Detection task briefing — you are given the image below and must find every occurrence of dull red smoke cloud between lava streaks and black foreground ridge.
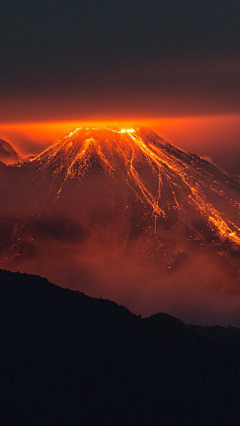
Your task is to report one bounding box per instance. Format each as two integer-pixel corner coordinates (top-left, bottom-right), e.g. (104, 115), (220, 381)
(0, 170), (240, 326)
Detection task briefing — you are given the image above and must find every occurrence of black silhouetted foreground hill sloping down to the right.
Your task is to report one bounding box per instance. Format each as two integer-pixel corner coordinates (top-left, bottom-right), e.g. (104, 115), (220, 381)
(0, 271), (240, 426)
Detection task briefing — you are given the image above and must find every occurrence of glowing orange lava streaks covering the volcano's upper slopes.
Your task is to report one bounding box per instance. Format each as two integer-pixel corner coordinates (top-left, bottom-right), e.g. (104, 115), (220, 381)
(31, 128), (240, 249)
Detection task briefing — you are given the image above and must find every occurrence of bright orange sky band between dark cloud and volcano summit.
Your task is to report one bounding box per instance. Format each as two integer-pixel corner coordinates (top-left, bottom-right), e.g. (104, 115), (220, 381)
(0, 114), (240, 173)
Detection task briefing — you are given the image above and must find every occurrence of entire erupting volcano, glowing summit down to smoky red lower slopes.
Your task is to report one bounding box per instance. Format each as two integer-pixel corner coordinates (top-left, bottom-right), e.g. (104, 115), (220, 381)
(0, 128), (240, 321)
